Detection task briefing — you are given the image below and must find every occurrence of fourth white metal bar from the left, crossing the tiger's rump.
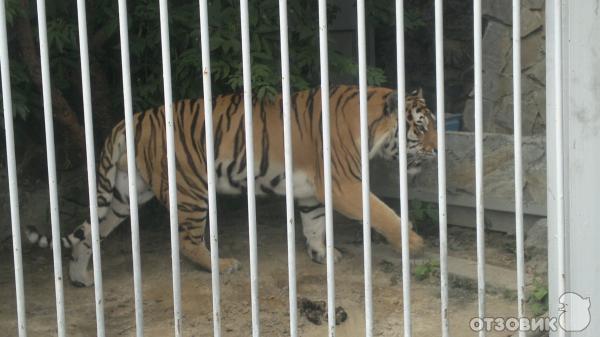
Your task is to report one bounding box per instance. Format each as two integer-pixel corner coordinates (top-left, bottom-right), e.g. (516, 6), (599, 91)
(119, 0), (144, 337)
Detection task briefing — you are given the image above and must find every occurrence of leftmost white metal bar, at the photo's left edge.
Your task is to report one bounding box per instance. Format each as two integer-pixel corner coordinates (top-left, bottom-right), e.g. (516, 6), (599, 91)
(0, 0), (27, 337)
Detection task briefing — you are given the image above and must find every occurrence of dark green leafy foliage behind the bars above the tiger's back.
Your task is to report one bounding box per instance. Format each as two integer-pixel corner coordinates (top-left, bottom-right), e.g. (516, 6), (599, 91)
(7, 0), (423, 120)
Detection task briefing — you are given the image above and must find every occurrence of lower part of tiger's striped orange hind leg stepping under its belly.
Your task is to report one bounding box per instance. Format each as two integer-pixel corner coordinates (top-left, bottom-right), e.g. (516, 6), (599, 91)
(178, 202), (240, 273)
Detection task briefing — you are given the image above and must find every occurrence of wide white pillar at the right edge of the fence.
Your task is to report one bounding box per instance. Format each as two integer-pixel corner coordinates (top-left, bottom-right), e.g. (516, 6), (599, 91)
(546, 0), (600, 337)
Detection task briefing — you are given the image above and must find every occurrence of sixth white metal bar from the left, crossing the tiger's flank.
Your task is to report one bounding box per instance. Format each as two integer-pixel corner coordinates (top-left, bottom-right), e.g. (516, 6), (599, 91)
(199, 0), (221, 337)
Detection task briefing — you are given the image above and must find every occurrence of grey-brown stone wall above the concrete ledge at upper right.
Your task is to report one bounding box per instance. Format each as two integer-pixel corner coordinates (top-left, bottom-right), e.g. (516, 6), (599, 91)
(463, 0), (546, 135)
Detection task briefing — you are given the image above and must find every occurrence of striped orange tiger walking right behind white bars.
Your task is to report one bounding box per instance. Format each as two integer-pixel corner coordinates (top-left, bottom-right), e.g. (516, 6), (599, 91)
(28, 85), (437, 286)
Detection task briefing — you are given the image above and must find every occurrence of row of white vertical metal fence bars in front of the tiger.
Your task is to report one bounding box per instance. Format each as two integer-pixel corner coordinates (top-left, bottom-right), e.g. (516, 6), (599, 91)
(0, 0), (592, 337)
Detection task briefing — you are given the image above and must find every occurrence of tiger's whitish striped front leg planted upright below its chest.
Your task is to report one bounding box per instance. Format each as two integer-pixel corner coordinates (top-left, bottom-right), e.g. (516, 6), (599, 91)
(298, 198), (342, 263)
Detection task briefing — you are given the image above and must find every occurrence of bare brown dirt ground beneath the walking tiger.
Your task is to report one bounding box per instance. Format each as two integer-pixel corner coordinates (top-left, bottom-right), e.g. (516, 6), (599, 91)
(0, 199), (516, 337)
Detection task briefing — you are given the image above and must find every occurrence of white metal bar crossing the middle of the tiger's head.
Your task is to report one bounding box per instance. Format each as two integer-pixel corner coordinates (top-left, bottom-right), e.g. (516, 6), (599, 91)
(396, 0), (412, 337)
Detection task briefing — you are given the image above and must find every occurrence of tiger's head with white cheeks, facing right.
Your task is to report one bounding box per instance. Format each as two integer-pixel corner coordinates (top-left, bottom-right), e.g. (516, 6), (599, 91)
(378, 89), (437, 175)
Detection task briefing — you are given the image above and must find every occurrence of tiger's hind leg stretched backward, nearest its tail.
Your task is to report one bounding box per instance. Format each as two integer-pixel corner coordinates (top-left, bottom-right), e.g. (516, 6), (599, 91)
(62, 171), (154, 287)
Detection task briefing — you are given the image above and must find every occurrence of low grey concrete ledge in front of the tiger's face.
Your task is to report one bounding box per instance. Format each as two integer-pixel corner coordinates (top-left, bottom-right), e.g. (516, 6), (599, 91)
(371, 132), (546, 233)
